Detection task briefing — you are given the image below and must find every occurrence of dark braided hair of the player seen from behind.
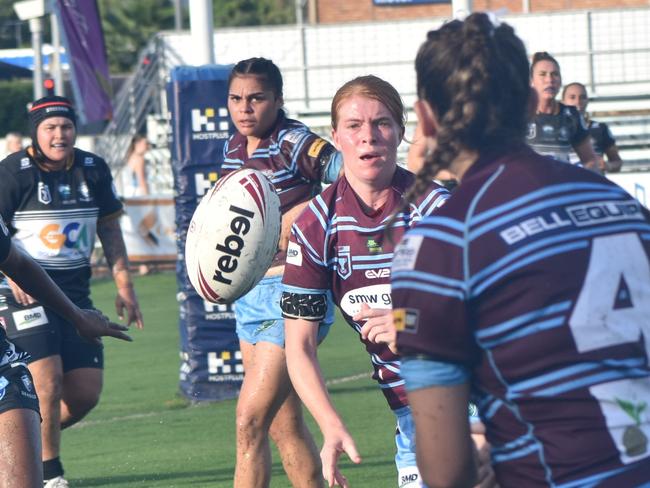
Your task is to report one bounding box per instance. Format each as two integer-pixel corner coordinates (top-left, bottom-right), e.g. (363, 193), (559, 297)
(405, 13), (530, 206)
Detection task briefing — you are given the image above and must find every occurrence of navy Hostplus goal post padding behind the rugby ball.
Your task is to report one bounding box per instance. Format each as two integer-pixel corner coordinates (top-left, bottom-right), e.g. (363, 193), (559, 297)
(167, 65), (244, 402)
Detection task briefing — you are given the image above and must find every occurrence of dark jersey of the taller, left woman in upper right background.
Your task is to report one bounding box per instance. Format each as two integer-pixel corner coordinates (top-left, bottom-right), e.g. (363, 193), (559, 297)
(527, 103), (589, 163)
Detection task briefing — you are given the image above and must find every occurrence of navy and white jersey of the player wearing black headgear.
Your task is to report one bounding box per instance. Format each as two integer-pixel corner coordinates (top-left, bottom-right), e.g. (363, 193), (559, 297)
(0, 149), (122, 301)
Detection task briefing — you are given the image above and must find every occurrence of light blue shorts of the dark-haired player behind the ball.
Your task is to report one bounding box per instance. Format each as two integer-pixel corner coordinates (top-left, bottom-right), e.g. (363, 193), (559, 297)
(235, 275), (334, 347)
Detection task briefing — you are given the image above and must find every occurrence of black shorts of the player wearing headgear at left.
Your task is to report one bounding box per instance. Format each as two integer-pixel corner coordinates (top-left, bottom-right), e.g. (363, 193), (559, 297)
(0, 292), (104, 372)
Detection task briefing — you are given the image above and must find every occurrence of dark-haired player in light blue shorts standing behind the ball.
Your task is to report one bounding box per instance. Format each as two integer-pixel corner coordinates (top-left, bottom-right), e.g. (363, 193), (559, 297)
(222, 58), (340, 488)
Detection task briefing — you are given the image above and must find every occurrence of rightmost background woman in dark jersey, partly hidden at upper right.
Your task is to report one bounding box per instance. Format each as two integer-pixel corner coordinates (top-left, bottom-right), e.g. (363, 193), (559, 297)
(562, 82), (623, 173)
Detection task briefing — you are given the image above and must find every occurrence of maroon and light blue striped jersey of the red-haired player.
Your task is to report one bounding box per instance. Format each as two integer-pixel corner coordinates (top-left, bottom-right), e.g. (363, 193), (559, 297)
(283, 168), (448, 409)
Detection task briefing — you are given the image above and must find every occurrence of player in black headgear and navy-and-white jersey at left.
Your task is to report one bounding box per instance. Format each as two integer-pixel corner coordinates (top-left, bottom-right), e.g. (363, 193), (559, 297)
(0, 96), (143, 488)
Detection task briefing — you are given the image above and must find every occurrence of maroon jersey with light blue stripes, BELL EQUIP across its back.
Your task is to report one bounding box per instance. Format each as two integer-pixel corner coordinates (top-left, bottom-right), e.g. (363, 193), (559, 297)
(392, 146), (650, 487)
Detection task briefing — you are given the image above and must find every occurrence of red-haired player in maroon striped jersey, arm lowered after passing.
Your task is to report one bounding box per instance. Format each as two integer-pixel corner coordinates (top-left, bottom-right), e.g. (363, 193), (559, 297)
(282, 76), (450, 487)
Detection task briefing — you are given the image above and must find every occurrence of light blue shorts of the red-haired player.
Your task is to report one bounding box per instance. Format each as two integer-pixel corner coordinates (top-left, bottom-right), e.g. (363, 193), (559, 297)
(393, 407), (426, 488)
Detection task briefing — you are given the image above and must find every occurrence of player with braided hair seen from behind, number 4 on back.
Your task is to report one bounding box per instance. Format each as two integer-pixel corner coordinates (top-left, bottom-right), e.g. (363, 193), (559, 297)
(392, 13), (650, 487)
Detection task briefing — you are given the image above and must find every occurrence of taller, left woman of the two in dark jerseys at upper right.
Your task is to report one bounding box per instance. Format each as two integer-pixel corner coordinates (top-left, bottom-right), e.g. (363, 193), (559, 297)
(527, 51), (600, 171)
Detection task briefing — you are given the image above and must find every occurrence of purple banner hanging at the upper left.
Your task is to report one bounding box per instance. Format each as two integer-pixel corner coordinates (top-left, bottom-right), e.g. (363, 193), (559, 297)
(54, 0), (113, 124)
